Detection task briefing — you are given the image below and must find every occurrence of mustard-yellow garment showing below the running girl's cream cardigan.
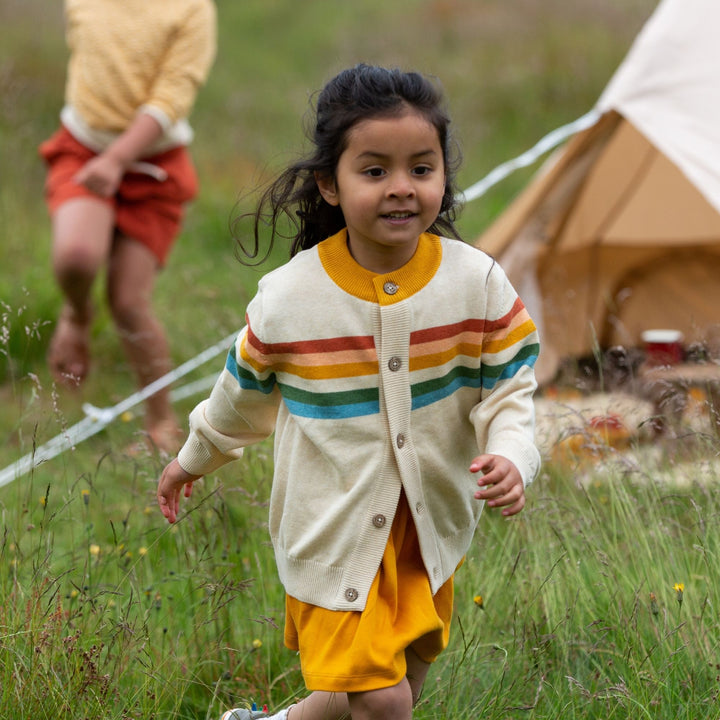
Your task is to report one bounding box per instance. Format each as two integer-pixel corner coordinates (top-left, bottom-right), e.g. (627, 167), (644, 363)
(285, 494), (453, 692)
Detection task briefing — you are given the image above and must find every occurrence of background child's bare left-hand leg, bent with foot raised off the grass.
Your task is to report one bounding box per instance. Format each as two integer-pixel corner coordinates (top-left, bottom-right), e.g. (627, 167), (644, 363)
(48, 198), (114, 387)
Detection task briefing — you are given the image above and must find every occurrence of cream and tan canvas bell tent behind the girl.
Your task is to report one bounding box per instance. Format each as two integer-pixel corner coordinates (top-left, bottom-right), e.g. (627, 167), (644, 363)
(476, 0), (720, 383)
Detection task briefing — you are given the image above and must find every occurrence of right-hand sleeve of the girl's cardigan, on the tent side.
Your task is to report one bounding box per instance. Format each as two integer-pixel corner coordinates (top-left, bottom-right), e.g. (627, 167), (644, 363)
(470, 265), (540, 486)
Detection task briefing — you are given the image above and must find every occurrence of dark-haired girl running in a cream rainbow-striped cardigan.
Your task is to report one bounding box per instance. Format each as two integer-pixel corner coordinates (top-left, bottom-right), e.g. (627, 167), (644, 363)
(158, 65), (539, 720)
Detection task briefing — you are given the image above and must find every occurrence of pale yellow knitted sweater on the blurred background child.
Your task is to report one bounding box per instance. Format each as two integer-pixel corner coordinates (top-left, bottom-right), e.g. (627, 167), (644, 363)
(62, 0), (216, 150)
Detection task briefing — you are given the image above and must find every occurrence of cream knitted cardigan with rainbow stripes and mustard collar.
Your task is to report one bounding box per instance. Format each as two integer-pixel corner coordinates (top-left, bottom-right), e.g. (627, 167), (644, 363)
(179, 231), (540, 610)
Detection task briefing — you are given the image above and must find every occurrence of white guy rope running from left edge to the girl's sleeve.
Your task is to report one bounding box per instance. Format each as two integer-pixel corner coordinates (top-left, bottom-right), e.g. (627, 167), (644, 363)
(0, 332), (237, 487)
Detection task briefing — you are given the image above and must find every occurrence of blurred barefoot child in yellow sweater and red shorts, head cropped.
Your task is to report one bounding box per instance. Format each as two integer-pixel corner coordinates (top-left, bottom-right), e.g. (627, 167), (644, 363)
(40, 0), (216, 452)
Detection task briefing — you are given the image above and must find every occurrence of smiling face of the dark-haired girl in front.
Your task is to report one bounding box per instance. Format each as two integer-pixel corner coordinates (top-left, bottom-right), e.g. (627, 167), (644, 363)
(316, 110), (445, 273)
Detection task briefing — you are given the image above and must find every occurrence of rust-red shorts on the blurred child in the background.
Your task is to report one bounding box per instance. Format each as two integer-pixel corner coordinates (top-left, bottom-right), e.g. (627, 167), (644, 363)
(39, 127), (198, 265)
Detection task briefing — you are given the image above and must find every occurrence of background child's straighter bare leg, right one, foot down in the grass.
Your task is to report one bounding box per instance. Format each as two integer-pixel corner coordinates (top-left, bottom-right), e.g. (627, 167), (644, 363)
(108, 237), (181, 453)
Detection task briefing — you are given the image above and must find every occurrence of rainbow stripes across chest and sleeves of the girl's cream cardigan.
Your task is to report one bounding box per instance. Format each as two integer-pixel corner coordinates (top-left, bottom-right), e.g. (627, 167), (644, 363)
(227, 231), (539, 419)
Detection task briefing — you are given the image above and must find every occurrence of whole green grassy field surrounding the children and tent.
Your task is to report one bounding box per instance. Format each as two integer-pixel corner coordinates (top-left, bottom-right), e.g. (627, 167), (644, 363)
(0, 0), (720, 720)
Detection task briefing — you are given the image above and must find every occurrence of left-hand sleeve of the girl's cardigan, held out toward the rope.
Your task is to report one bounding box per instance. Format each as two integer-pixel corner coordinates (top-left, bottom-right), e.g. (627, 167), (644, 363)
(178, 326), (280, 475)
